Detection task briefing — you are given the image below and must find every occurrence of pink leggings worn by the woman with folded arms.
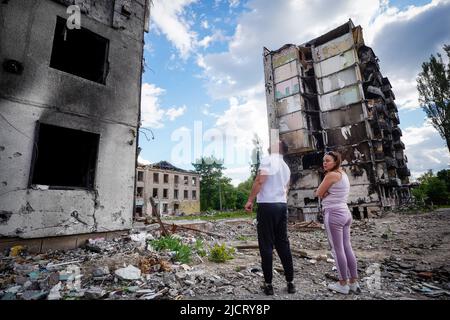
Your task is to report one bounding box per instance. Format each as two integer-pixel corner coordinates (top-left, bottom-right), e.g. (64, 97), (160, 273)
(324, 208), (358, 280)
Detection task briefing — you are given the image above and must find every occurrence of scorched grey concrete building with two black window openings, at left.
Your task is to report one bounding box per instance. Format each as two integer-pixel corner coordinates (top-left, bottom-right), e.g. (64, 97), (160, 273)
(0, 0), (151, 251)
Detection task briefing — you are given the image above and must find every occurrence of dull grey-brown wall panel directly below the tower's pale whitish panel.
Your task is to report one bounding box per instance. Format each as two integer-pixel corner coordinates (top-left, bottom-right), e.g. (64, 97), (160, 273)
(321, 103), (364, 129)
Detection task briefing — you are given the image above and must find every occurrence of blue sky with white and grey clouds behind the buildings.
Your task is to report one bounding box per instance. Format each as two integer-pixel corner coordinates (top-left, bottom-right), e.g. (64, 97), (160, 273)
(139, 0), (450, 183)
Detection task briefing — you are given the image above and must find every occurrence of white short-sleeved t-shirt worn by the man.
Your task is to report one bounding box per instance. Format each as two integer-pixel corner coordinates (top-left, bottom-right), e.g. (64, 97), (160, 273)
(256, 153), (291, 203)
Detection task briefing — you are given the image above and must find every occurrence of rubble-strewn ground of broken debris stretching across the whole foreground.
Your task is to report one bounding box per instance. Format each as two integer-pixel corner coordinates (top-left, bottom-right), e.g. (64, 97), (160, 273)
(0, 209), (450, 300)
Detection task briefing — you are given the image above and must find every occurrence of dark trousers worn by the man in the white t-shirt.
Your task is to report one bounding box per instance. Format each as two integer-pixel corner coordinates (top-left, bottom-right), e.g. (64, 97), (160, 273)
(256, 203), (294, 283)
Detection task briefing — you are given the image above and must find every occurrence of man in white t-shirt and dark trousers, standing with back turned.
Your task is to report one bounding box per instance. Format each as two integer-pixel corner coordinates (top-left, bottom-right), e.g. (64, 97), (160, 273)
(245, 141), (295, 295)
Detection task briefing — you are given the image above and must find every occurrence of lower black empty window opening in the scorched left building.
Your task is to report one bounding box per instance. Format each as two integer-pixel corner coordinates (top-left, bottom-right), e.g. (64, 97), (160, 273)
(28, 122), (100, 189)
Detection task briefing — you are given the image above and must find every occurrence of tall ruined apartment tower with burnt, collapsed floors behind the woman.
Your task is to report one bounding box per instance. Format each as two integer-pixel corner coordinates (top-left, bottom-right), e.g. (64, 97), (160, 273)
(263, 20), (410, 221)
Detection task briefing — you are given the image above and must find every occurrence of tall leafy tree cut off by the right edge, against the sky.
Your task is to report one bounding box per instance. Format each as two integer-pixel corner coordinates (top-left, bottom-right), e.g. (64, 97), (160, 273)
(417, 45), (450, 151)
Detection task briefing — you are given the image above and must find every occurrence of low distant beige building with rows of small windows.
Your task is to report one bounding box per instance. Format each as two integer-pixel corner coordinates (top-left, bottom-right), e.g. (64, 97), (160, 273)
(135, 161), (200, 219)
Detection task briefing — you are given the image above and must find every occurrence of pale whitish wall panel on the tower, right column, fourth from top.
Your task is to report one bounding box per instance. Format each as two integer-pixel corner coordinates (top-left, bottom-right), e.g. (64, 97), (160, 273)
(319, 85), (363, 111)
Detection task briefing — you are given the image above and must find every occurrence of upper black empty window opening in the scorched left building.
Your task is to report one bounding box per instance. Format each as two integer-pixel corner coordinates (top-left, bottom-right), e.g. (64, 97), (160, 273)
(50, 17), (109, 84)
